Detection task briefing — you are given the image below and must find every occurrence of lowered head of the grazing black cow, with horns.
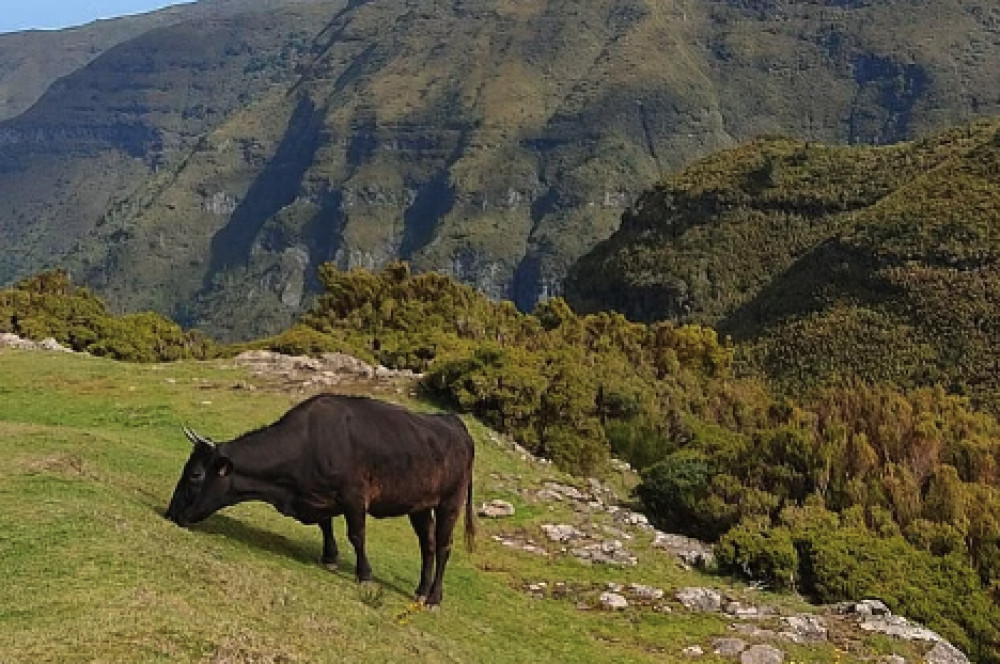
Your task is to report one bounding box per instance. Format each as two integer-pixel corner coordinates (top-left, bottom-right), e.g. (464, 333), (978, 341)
(165, 427), (233, 526)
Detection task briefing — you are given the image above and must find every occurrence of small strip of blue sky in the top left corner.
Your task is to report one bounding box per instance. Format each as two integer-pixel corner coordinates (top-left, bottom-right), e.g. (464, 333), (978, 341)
(0, 0), (193, 32)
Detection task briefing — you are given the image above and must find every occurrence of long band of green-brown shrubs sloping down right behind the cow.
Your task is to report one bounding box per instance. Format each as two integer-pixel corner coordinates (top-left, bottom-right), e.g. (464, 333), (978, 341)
(278, 265), (1000, 662)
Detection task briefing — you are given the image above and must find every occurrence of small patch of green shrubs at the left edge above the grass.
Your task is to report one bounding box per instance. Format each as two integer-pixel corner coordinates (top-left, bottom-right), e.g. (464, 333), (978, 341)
(0, 271), (213, 362)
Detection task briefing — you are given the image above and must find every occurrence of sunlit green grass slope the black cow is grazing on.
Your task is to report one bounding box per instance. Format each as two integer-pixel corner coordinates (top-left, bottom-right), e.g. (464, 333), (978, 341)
(0, 351), (920, 664)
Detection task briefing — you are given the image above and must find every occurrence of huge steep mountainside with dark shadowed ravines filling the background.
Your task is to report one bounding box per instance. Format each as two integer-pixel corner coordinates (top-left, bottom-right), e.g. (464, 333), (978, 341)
(0, 0), (1000, 338)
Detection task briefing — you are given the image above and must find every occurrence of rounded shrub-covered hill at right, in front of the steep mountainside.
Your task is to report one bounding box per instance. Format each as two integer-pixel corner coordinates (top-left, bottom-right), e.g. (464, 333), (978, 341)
(567, 120), (1000, 411)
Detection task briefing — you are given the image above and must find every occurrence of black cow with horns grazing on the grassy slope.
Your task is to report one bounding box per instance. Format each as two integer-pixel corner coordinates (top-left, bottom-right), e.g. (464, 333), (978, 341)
(166, 395), (475, 606)
